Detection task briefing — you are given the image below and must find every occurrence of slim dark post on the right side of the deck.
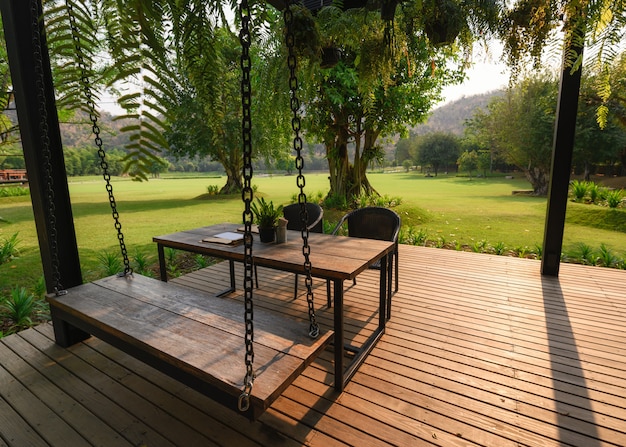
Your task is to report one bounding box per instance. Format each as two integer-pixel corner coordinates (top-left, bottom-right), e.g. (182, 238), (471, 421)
(541, 18), (584, 276)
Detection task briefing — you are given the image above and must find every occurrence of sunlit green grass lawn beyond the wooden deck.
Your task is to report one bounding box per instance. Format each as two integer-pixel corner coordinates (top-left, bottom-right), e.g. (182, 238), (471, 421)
(0, 173), (626, 290)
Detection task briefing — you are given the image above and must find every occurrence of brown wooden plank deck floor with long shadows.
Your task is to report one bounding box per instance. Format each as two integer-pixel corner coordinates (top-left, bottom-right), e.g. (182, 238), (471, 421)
(0, 246), (626, 447)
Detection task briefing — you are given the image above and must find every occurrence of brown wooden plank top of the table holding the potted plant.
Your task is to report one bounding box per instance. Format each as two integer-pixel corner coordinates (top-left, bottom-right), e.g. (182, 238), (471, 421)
(153, 224), (394, 280)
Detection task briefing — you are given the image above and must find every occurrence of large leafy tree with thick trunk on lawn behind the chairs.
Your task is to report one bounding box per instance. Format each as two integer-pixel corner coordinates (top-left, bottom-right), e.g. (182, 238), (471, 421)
(292, 2), (502, 202)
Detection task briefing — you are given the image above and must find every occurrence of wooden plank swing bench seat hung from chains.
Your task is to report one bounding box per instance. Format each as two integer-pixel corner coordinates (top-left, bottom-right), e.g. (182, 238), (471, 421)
(48, 275), (333, 419)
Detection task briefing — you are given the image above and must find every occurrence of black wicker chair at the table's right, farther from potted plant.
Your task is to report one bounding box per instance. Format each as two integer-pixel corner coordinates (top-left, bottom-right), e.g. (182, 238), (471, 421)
(326, 206), (401, 318)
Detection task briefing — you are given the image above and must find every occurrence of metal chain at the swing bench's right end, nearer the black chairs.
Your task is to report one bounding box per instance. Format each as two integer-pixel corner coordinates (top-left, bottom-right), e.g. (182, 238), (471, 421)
(283, 1), (320, 338)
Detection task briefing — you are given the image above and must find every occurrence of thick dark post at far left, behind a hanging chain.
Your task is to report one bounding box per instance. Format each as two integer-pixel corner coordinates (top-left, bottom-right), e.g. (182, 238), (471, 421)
(0, 0), (82, 292)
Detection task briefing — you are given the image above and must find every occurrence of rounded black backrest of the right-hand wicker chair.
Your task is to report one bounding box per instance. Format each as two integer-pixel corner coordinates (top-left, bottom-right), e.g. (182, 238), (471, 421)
(336, 206), (400, 242)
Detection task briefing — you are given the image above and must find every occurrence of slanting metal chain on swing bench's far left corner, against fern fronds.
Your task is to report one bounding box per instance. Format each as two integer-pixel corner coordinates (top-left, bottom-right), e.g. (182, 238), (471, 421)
(65, 1), (133, 276)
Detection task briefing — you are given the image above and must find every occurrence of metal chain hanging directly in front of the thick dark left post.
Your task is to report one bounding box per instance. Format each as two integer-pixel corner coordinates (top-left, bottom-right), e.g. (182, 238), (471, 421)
(30, 0), (67, 296)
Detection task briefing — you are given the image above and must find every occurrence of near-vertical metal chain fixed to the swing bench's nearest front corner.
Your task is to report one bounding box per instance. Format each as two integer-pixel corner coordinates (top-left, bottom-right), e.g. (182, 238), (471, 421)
(238, 0), (255, 411)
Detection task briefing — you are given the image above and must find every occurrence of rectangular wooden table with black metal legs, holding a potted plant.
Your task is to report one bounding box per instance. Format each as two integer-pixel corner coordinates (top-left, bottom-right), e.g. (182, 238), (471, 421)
(153, 224), (394, 392)
